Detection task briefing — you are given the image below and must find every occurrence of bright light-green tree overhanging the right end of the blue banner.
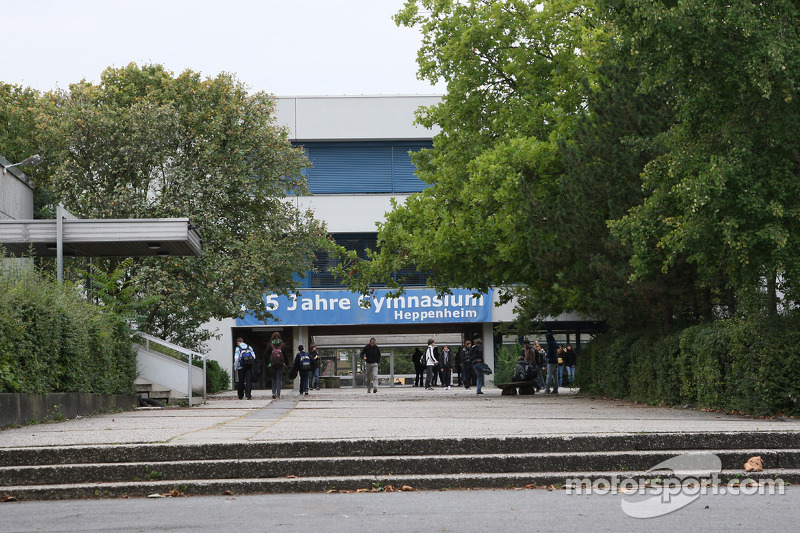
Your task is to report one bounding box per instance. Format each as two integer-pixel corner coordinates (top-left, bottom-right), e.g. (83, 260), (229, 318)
(340, 0), (593, 330)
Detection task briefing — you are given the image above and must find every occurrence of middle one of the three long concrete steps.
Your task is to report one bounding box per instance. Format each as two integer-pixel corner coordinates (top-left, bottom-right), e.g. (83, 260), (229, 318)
(0, 450), (800, 486)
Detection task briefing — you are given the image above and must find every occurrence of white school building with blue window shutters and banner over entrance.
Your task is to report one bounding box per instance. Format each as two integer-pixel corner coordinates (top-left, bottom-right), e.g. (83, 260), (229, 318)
(207, 95), (593, 387)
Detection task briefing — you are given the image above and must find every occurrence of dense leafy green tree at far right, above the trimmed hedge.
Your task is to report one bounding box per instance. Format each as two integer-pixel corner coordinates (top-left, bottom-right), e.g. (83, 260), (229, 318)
(603, 0), (800, 312)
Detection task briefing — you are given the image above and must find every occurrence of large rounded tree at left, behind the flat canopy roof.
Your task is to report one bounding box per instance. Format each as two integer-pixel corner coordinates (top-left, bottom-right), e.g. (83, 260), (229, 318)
(25, 64), (326, 345)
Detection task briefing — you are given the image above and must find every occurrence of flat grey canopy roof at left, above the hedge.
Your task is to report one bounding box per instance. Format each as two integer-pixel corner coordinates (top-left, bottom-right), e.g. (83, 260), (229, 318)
(0, 218), (202, 257)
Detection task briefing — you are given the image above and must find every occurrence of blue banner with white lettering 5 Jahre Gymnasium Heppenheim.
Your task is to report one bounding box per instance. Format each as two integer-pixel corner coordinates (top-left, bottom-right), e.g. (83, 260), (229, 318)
(236, 289), (492, 327)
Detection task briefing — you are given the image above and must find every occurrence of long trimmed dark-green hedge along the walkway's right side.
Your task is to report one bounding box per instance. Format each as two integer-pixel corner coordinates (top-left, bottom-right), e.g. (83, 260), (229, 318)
(577, 317), (800, 416)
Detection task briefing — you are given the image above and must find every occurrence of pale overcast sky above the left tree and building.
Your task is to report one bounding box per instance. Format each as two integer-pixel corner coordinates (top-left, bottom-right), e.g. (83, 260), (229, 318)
(0, 0), (444, 96)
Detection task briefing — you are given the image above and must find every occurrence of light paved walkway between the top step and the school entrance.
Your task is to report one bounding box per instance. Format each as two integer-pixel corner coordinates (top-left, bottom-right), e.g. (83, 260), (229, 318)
(0, 386), (800, 448)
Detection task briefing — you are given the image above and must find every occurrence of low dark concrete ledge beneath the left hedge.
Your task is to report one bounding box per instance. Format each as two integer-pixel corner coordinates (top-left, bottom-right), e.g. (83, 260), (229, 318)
(0, 392), (138, 427)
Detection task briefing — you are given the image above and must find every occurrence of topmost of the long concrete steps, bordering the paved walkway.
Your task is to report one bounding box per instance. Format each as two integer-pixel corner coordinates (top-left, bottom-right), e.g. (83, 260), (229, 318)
(6, 432), (800, 466)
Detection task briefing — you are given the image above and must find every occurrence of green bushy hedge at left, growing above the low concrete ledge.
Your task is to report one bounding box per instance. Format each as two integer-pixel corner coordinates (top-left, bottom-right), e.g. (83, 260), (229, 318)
(0, 270), (136, 394)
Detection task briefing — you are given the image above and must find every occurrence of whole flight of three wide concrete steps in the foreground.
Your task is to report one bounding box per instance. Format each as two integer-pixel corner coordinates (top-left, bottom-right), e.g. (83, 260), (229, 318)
(0, 432), (800, 500)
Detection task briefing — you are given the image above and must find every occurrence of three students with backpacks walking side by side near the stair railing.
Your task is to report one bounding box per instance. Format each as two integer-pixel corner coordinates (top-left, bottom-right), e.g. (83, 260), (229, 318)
(233, 331), (320, 400)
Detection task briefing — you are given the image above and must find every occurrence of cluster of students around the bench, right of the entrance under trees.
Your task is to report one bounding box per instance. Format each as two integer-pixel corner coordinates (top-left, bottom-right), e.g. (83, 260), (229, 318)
(511, 331), (578, 394)
